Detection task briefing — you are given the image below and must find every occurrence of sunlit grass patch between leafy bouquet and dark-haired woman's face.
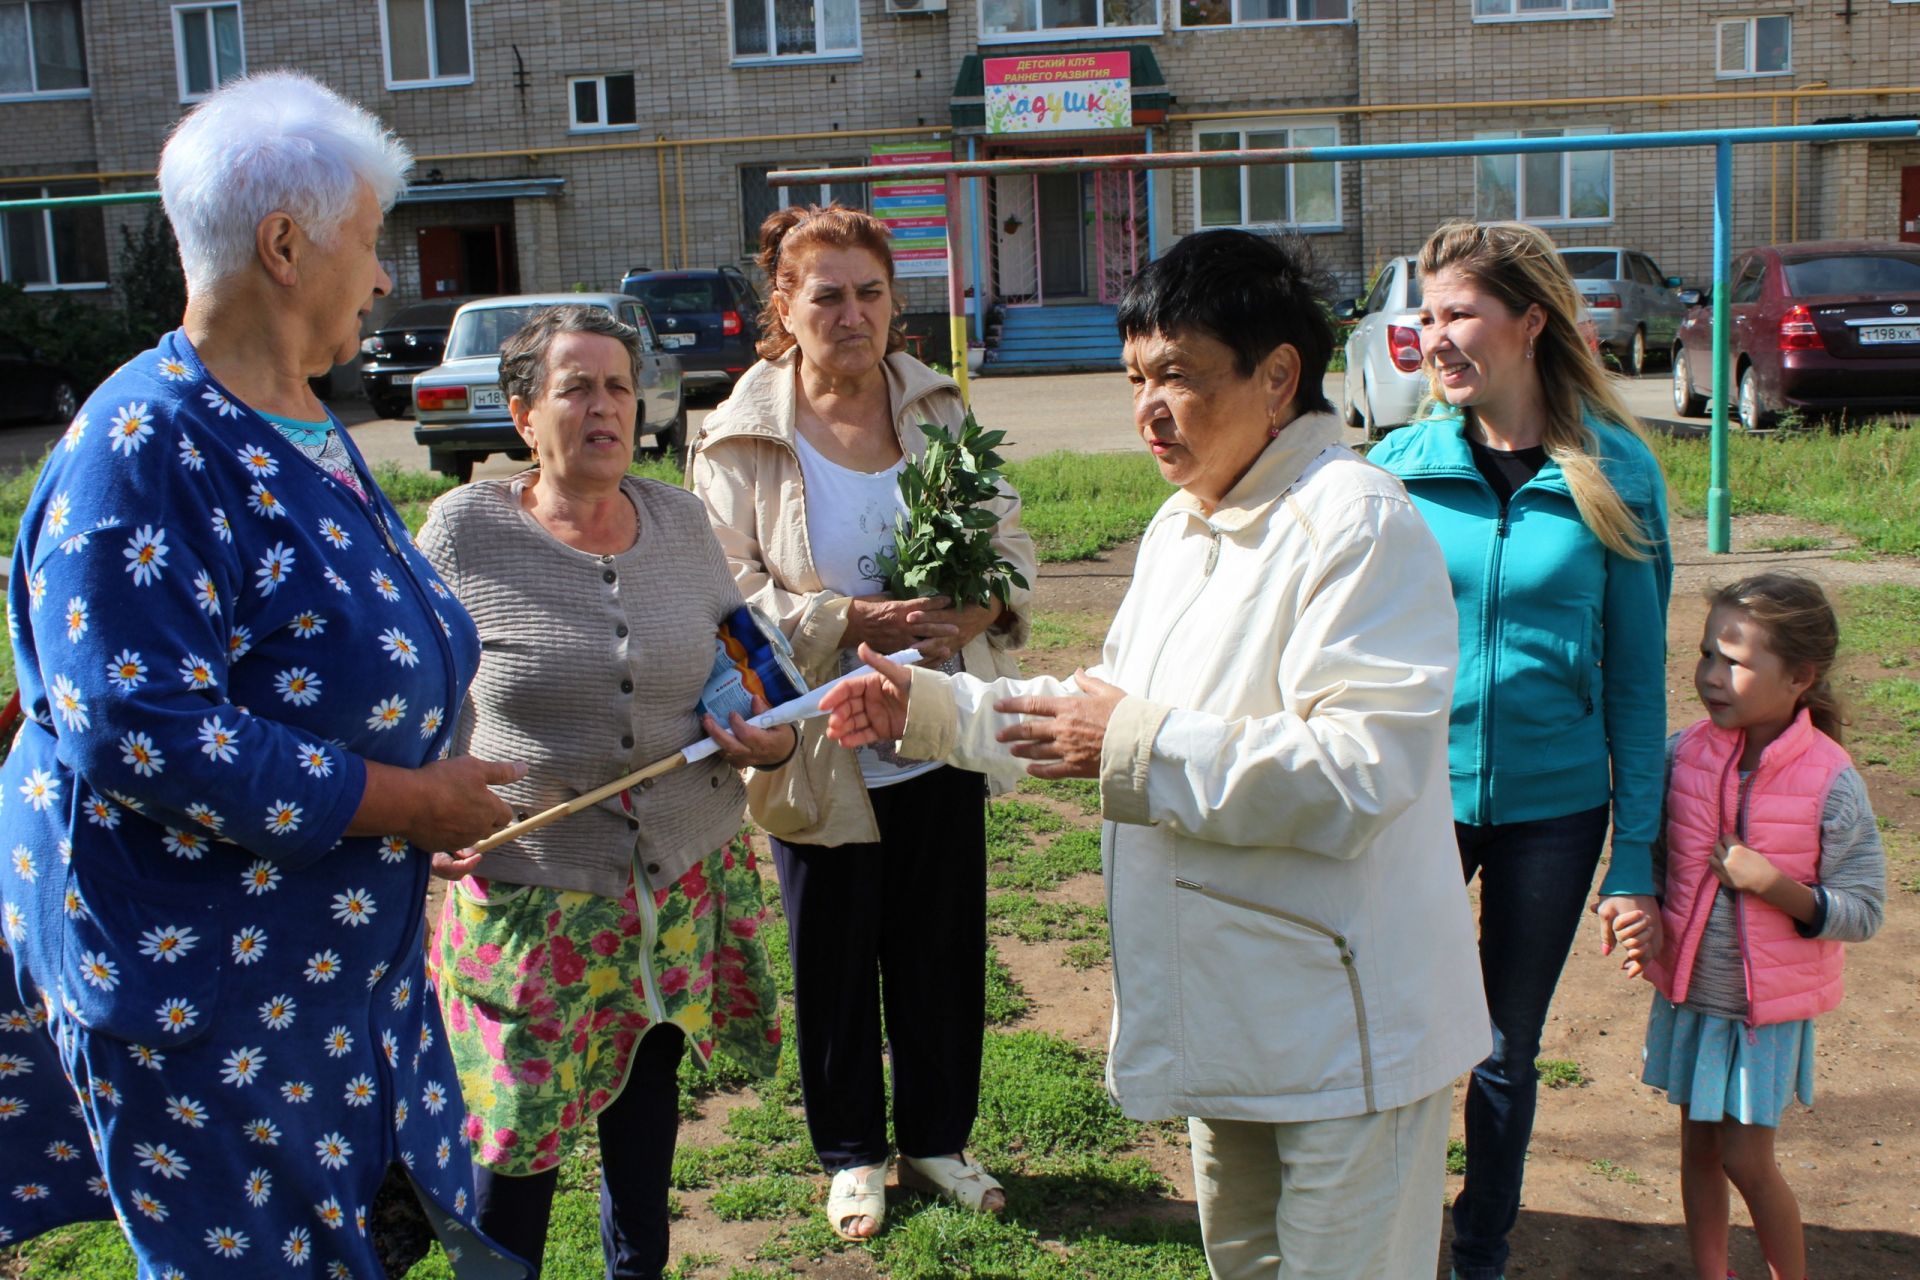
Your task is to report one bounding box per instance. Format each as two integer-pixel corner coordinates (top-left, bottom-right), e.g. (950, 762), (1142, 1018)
(1004, 453), (1173, 560)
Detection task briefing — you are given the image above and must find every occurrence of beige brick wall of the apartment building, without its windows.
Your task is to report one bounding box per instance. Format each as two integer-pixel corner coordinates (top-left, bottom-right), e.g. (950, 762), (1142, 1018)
(0, 0), (1920, 309)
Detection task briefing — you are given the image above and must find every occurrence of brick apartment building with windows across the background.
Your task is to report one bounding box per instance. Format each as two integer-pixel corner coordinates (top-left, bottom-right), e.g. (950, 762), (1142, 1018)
(0, 0), (1920, 360)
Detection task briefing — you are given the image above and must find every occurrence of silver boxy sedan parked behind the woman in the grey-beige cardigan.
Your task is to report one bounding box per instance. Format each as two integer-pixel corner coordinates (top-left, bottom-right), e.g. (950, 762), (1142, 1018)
(413, 294), (687, 484)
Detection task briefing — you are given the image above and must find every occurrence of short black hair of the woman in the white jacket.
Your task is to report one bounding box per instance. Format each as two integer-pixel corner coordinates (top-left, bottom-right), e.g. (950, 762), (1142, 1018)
(1117, 228), (1332, 413)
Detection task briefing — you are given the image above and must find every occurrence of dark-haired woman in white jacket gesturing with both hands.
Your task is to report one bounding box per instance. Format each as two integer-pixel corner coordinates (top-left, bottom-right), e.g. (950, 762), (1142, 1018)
(828, 230), (1488, 1280)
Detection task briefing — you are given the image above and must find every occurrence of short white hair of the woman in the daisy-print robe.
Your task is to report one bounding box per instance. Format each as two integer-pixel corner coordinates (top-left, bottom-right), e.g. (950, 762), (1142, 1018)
(159, 71), (413, 292)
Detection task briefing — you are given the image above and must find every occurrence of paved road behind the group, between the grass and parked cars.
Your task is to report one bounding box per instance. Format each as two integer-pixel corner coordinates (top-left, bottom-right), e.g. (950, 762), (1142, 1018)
(0, 372), (1707, 485)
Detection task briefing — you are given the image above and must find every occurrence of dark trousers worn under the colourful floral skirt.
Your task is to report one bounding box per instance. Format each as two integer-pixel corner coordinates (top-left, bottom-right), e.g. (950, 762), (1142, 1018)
(474, 1023), (687, 1280)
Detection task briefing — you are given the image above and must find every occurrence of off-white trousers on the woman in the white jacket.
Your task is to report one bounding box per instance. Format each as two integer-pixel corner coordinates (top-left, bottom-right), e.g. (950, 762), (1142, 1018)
(1187, 1088), (1452, 1280)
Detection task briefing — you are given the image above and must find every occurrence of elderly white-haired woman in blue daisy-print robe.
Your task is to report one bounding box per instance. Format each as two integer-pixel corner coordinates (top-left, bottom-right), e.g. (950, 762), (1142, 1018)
(0, 73), (526, 1278)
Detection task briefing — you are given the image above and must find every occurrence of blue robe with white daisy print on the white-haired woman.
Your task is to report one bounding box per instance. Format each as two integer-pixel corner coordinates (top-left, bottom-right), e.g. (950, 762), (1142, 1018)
(0, 334), (495, 1280)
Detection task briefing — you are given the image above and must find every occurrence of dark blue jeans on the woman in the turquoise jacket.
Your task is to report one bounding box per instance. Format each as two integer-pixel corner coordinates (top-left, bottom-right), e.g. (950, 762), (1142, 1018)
(1453, 804), (1607, 1280)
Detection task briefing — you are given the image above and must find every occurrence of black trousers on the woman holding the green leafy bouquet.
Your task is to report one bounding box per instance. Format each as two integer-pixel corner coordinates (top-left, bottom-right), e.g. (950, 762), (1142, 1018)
(774, 768), (987, 1173)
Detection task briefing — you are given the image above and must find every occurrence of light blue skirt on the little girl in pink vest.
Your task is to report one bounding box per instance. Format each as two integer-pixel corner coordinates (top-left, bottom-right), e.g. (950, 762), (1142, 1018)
(1640, 992), (1812, 1128)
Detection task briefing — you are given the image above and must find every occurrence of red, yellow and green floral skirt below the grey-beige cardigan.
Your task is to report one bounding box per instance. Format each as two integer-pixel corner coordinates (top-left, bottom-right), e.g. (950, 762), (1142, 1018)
(434, 837), (780, 1174)
